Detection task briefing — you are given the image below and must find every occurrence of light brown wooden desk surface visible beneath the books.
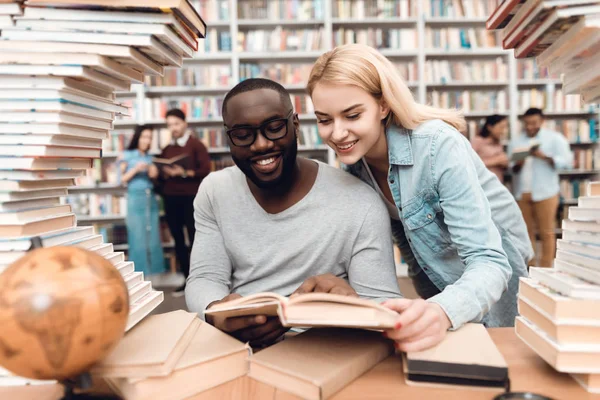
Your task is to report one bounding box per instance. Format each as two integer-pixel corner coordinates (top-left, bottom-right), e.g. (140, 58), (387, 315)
(0, 328), (600, 400)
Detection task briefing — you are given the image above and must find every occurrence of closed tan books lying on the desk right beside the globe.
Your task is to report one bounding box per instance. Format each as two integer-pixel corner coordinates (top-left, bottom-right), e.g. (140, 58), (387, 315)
(92, 310), (251, 400)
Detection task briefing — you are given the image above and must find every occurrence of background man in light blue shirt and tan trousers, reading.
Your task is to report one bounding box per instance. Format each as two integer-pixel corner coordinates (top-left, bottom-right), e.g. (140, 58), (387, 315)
(511, 108), (573, 267)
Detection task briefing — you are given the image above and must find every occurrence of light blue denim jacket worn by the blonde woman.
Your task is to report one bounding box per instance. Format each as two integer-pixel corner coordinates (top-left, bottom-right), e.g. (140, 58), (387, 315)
(348, 120), (533, 329)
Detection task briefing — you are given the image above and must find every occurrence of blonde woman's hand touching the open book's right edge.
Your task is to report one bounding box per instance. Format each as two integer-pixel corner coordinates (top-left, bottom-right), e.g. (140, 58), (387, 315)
(382, 299), (452, 352)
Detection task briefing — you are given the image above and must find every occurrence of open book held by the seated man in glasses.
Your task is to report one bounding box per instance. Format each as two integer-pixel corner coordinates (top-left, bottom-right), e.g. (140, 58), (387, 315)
(205, 293), (398, 329)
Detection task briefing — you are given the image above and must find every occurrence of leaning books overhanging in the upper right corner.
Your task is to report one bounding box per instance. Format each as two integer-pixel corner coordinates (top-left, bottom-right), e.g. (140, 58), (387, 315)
(487, 0), (600, 103)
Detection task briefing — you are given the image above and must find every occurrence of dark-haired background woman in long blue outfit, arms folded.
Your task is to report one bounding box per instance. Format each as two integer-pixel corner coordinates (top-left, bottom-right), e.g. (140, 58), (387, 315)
(120, 125), (165, 277)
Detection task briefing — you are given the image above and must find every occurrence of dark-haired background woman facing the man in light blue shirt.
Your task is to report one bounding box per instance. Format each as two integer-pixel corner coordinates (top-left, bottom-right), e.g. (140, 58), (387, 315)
(471, 114), (508, 183)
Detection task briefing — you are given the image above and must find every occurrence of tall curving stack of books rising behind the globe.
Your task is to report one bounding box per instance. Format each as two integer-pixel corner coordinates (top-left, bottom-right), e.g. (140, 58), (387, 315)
(0, 0), (206, 330)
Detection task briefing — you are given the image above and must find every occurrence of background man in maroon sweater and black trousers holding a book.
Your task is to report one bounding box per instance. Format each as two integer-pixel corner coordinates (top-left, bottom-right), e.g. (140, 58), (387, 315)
(160, 108), (210, 296)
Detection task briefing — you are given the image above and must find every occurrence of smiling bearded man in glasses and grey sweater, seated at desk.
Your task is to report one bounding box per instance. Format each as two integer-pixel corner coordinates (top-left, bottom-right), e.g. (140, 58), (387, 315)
(186, 79), (400, 345)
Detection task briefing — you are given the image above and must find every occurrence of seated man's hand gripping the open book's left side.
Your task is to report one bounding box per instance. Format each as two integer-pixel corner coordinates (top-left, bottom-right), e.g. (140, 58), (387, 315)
(206, 293), (288, 347)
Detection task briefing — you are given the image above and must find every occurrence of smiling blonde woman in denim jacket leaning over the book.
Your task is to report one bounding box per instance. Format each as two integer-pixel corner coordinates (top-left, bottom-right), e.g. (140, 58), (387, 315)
(308, 44), (532, 351)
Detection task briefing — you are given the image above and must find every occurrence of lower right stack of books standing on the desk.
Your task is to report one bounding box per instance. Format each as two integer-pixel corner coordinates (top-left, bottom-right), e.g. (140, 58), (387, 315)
(515, 182), (600, 393)
